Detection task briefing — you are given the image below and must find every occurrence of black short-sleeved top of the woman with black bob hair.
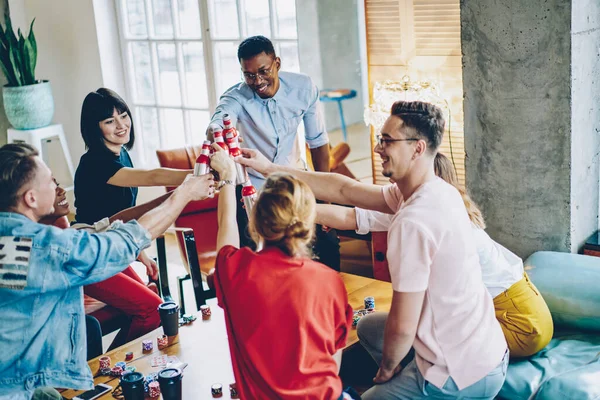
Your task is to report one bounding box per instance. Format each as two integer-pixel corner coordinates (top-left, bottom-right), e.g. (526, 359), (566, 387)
(75, 148), (138, 224)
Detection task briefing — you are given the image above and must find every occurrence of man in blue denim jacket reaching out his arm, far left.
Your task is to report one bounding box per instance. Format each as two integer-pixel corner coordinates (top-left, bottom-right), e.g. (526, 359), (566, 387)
(0, 144), (214, 399)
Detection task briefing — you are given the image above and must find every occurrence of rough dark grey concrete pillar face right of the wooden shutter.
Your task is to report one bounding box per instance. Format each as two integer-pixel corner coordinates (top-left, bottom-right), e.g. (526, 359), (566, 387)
(461, 0), (572, 257)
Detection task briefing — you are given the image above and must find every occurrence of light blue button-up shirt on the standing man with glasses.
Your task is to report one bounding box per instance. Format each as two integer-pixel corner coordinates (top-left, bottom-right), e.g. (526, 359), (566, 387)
(211, 72), (329, 189)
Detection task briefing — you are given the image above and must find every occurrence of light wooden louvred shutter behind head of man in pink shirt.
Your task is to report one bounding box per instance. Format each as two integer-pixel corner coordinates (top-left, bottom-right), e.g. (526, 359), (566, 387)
(365, 0), (465, 184)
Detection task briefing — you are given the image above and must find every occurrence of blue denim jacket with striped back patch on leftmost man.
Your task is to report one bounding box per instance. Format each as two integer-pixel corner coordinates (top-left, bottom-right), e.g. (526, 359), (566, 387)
(0, 212), (151, 396)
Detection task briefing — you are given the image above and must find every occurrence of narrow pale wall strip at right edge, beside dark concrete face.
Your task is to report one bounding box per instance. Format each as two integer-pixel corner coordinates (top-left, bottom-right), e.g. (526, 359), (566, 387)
(571, 0), (600, 251)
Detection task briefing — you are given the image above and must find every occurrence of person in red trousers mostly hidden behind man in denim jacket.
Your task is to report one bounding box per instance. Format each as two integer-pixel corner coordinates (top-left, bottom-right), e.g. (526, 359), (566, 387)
(40, 182), (169, 350)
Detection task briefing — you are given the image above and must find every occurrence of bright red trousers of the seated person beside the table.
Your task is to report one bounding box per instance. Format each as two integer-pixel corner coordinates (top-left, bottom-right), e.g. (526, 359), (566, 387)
(83, 267), (163, 350)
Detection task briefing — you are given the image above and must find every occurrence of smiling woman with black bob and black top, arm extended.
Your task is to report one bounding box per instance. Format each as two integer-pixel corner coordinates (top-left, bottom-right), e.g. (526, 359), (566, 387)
(75, 88), (192, 224)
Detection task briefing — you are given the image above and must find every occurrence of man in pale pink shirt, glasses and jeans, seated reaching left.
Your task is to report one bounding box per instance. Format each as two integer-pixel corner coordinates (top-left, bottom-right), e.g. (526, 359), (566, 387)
(238, 101), (508, 399)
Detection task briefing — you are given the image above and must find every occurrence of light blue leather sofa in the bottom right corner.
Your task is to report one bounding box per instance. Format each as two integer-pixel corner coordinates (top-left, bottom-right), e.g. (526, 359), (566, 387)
(498, 251), (600, 400)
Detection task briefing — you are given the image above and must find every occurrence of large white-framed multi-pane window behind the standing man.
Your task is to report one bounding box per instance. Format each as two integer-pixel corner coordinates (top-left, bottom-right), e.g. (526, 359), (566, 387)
(116, 0), (300, 166)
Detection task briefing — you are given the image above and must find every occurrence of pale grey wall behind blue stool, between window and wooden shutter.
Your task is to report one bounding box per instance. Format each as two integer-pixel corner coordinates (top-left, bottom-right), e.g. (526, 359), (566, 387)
(296, 0), (368, 130)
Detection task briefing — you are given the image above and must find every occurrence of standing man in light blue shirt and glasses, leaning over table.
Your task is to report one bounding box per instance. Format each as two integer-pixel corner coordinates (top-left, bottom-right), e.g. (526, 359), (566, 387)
(209, 36), (340, 270)
